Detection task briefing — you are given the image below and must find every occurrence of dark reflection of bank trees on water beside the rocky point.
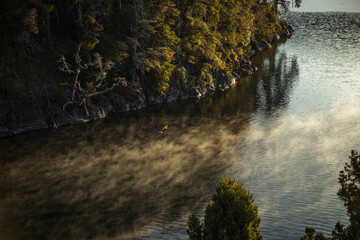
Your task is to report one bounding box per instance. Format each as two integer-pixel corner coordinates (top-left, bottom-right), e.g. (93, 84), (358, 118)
(156, 41), (299, 119)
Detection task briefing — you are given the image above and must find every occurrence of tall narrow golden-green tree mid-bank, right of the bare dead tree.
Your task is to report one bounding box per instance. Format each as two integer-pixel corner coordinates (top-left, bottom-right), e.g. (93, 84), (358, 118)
(137, 0), (180, 95)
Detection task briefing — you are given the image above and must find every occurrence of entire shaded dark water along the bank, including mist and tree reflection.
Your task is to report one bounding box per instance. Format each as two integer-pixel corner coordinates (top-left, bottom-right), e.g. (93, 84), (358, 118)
(0, 40), (299, 239)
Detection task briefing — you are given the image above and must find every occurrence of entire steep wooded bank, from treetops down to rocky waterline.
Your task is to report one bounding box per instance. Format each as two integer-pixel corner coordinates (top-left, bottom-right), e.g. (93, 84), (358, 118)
(0, 0), (292, 136)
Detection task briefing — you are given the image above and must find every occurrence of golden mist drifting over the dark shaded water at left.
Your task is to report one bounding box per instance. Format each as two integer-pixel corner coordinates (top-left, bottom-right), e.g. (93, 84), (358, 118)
(0, 108), (245, 239)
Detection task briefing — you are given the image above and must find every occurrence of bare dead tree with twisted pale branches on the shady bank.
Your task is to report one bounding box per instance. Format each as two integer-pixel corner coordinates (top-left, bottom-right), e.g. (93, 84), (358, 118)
(58, 45), (127, 115)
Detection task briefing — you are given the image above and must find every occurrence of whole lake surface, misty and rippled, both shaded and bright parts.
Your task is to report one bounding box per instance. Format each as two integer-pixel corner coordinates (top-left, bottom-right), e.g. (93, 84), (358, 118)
(0, 13), (360, 240)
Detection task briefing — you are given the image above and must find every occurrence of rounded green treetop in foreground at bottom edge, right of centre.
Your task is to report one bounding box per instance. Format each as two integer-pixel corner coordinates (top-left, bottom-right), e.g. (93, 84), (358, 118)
(187, 178), (263, 240)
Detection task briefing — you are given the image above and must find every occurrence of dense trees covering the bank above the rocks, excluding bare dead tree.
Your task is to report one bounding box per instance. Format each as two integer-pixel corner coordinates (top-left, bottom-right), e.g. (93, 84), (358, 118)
(0, 0), (294, 129)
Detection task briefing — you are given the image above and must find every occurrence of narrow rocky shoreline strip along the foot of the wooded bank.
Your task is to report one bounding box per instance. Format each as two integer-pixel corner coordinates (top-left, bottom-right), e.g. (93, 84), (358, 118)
(0, 22), (293, 137)
